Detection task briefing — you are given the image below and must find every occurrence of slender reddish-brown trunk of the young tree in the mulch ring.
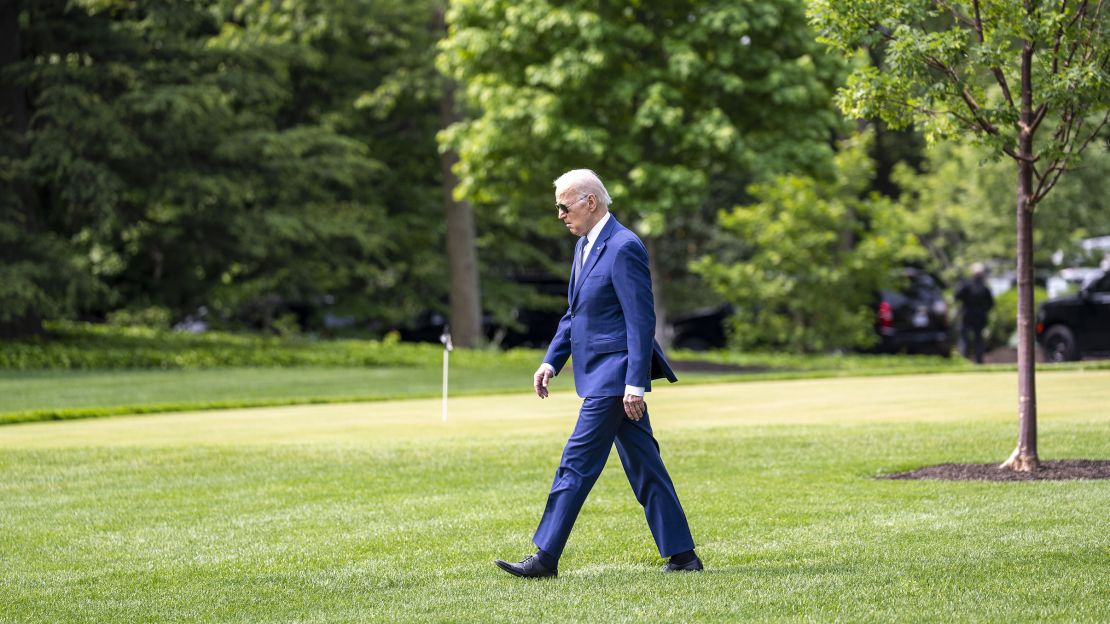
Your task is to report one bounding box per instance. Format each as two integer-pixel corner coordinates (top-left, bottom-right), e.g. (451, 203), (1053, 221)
(999, 42), (1040, 472)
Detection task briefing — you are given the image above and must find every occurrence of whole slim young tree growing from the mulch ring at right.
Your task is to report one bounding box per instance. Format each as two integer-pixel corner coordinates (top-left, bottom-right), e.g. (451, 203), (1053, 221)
(809, 0), (1110, 471)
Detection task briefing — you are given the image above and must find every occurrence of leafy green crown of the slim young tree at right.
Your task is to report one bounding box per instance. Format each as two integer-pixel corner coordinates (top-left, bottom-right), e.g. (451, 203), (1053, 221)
(809, 0), (1110, 143)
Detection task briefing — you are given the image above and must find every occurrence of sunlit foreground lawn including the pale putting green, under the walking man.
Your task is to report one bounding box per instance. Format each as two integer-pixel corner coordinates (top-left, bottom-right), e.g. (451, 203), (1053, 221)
(0, 371), (1110, 622)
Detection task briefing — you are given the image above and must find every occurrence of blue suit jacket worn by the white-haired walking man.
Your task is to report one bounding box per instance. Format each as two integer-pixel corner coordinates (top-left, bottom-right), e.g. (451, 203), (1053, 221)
(544, 217), (678, 397)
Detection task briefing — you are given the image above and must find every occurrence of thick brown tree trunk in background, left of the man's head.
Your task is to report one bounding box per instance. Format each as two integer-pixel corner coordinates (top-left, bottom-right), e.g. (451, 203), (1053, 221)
(440, 80), (482, 348)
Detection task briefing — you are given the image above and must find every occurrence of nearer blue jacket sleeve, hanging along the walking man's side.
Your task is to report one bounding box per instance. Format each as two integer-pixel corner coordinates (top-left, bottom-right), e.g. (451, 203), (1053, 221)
(613, 240), (655, 388)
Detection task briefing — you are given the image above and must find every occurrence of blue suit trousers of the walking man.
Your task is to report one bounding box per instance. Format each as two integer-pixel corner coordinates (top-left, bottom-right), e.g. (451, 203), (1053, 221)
(532, 396), (694, 557)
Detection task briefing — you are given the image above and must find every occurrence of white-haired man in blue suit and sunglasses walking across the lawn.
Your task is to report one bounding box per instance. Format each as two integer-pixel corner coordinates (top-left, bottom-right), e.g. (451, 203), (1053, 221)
(494, 169), (702, 577)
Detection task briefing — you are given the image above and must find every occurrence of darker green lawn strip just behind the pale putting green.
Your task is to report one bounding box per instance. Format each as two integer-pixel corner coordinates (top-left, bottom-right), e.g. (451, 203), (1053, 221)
(0, 353), (960, 424)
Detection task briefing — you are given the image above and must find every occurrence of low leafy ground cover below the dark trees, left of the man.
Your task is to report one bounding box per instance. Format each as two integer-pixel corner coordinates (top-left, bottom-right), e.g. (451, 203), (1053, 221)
(0, 322), (537, 371)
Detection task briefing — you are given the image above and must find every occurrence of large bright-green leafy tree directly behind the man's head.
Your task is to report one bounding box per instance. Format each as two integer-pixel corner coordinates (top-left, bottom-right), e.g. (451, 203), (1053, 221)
(442, 0), (840, 339)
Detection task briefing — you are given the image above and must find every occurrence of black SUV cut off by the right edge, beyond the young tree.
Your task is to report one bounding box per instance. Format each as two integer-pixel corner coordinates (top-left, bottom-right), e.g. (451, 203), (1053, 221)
(1037, 271), (1110, 362)
